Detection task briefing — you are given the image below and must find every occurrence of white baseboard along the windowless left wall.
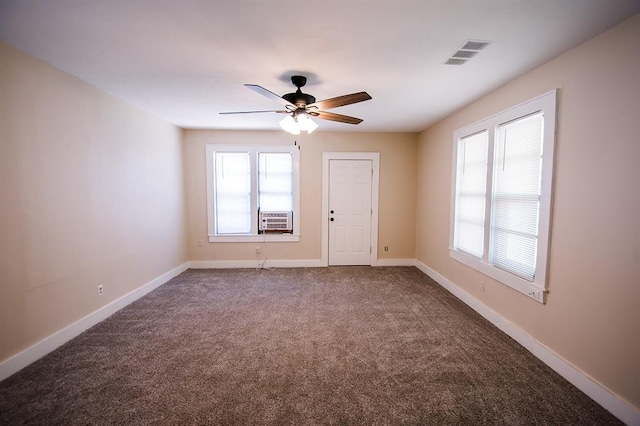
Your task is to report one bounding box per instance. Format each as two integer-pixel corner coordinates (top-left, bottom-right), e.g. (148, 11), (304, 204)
(0, 263), (188, 381)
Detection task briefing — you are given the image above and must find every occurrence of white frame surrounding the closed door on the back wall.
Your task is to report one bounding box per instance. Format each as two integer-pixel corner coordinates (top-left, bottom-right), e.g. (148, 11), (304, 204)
(321, 152), (380, 266)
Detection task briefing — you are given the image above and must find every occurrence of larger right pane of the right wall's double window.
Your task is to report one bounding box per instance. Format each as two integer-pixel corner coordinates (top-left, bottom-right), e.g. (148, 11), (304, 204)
(491, 113), (544, 281)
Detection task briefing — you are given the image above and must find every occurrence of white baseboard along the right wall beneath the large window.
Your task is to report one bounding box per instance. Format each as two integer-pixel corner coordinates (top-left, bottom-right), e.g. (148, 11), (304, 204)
(414, 260), (640, 425)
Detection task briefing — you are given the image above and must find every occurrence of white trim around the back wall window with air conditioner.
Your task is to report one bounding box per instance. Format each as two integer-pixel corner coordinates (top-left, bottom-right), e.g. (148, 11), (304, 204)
(206, 144), (300, 243)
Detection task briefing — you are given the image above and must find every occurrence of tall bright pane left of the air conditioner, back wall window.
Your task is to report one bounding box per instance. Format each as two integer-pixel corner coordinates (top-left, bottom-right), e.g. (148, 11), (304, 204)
(215, 152), (251, 234)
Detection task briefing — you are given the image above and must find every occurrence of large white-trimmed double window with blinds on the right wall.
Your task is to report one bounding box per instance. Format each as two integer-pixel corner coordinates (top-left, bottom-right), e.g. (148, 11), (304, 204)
(450, 90), (556, 303)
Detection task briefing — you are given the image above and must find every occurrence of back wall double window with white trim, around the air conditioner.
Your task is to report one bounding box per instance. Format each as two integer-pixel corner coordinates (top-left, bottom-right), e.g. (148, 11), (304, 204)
(206, 145), (300, 242)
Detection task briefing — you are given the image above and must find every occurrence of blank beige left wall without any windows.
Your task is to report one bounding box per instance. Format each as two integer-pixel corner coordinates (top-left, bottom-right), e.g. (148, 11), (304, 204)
(0, 43), (187, 362)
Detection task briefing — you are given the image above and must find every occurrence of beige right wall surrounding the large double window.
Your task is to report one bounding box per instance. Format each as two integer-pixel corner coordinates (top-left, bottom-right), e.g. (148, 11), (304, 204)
(417, 15), (640, 408)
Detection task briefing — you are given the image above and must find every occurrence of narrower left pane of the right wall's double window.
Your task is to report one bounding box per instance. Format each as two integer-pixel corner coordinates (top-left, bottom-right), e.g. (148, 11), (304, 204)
(454, 132), (489, 257)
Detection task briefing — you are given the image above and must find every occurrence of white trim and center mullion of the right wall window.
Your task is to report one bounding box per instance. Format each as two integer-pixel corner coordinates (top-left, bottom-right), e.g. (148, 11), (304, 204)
(449, 89), (557, 303)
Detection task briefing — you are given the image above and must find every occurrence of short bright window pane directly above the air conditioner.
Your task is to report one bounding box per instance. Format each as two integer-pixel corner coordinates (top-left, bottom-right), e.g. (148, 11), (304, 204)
(258, 152), (293, 211)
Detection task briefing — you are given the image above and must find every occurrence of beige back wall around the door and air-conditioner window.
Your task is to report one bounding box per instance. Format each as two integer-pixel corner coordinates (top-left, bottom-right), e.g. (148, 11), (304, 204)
(183, 130), (417, 260)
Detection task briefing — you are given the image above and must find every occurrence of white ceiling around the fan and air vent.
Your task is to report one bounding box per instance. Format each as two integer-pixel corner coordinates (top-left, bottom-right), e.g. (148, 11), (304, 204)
(0, 0), (640, 132)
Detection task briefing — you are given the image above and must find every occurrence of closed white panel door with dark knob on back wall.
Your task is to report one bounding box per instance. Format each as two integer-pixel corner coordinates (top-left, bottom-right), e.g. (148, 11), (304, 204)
(329, 160), (372, 265)
